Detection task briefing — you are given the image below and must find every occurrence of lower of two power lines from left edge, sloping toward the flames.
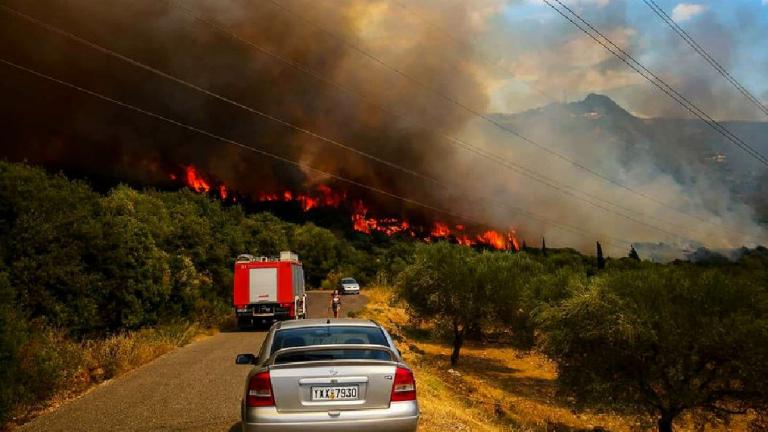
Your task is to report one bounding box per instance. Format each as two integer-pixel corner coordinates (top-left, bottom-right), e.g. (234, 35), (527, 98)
(0, 58), (631, 253)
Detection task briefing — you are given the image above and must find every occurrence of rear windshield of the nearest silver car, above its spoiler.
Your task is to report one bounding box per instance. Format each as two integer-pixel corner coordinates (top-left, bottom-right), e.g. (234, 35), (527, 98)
(270, 325), (389, 354)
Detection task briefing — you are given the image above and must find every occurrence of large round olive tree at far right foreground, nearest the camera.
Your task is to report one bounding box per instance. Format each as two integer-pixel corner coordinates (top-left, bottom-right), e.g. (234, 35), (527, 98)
(541, 265), (768, 432)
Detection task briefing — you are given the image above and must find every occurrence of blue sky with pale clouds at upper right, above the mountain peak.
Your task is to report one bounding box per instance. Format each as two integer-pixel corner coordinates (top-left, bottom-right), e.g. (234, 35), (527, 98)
(479, 0), (768, 121)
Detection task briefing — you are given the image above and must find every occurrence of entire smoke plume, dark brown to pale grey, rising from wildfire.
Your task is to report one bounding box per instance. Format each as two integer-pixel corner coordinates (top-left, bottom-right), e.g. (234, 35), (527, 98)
(0, 0), (764, 254)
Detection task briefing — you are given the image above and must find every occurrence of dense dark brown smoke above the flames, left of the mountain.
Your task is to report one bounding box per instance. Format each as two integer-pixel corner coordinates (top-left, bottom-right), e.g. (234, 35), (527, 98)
(0, 0), (486, 213)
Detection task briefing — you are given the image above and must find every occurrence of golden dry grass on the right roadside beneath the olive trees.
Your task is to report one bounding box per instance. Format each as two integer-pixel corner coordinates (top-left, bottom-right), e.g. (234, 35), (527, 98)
(359, 287), (746, 432)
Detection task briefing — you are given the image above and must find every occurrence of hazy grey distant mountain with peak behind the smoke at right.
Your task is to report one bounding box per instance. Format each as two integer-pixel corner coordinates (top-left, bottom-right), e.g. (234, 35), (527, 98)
(493, 94), (768, 221)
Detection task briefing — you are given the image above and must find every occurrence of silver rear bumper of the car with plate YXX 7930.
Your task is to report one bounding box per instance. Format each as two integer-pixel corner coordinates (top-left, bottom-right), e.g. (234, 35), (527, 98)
(242, 401), (419, 432)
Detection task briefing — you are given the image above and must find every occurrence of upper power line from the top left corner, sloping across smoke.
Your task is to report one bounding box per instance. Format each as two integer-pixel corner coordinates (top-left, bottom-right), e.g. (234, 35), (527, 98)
(0, 2), (687, 240)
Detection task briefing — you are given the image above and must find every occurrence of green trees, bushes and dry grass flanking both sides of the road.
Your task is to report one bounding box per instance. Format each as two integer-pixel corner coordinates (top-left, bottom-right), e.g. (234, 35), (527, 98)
(0, 162), (768, 432)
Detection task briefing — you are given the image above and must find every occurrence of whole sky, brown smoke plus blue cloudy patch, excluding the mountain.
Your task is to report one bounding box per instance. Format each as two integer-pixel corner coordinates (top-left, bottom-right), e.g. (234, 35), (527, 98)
(0, 0), (768, 254)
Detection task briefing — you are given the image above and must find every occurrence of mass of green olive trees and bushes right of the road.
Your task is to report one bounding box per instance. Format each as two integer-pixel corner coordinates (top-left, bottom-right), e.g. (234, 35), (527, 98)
(397, 243), (768, 432)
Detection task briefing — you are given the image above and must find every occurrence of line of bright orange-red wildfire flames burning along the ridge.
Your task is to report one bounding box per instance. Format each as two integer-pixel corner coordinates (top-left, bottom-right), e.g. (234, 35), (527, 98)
(170, 165), (520, 251)
